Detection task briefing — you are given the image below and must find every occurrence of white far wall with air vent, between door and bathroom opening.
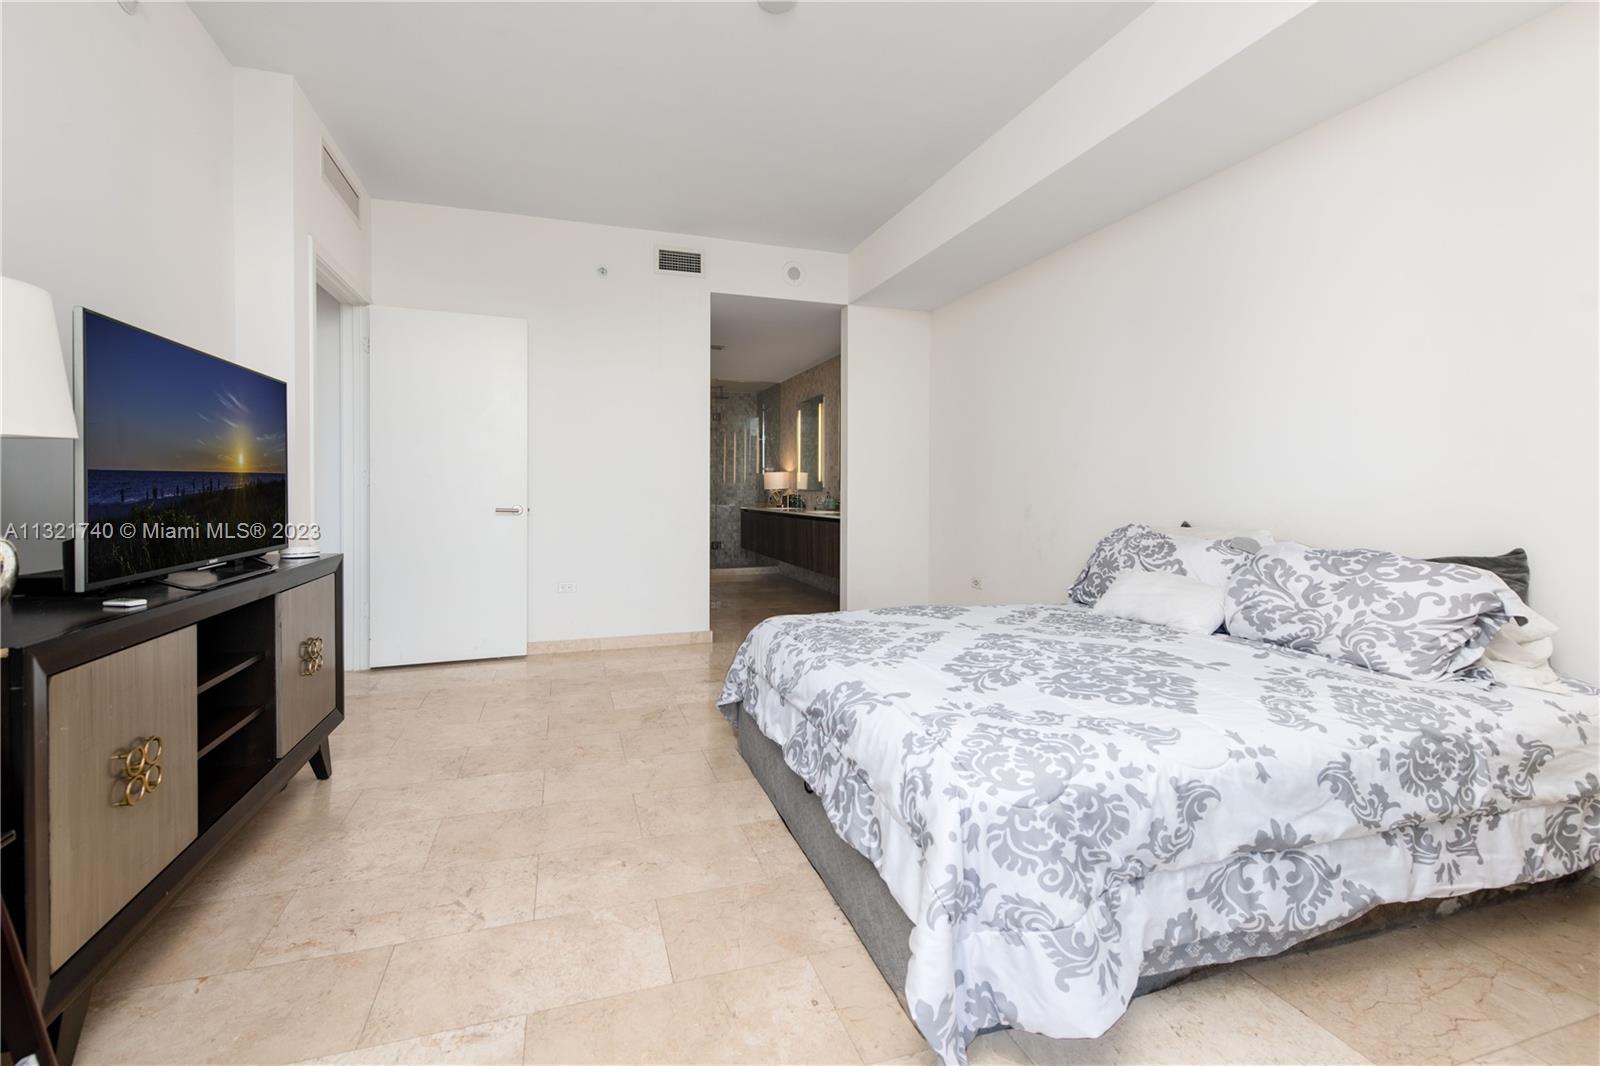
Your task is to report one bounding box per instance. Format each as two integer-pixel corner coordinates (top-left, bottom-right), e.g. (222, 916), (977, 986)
(371, 200), (845, 642)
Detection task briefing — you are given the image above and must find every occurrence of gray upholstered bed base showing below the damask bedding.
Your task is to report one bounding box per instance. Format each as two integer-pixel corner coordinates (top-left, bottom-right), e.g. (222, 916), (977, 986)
(736, 707), (1586, 1007)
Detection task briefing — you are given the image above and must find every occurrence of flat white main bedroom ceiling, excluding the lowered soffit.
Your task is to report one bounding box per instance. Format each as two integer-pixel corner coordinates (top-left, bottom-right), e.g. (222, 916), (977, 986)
(190, 0), (1147, 251)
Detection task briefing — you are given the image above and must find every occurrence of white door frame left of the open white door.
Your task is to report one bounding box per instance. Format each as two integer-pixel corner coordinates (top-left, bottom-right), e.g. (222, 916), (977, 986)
(307, 244), (371, 672)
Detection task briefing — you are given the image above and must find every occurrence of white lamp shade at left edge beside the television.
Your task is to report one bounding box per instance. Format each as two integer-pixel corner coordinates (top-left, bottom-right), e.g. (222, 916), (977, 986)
(0, 279), (78, 437)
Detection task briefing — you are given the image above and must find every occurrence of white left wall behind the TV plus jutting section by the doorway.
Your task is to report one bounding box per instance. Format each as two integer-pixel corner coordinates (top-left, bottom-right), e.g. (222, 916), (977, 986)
(0, 3), (370, 570)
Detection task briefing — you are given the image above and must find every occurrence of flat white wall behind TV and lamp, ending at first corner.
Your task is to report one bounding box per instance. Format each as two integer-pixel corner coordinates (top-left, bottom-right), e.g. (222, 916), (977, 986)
(0, 3), (234, 570)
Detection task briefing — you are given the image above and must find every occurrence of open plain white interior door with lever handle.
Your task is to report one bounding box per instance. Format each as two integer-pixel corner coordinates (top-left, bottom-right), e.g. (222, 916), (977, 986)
(368, 307), (528, 666)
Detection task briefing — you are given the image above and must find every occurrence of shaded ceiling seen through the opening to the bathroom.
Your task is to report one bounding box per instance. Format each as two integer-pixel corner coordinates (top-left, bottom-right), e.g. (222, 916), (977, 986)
(710, 293), (840, 383)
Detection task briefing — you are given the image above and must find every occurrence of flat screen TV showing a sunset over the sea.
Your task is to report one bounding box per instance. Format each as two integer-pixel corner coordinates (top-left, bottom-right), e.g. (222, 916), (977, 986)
(72, 307), (288, 592)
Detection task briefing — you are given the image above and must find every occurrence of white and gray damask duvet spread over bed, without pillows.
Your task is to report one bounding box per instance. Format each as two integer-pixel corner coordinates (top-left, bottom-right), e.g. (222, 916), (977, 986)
(718, 605), (1600, 1063)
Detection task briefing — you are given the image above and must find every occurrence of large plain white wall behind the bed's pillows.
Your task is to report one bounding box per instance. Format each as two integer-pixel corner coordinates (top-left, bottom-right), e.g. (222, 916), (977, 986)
(928, 5), (1600, 680)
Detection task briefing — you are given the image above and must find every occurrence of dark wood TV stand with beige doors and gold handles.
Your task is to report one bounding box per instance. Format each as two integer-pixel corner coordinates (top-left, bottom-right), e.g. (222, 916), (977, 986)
(0, 555), (344, 1066)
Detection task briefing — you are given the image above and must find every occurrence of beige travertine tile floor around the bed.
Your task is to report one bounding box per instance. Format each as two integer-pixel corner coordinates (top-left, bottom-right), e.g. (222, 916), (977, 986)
(80, 578), (1600, 1063)
